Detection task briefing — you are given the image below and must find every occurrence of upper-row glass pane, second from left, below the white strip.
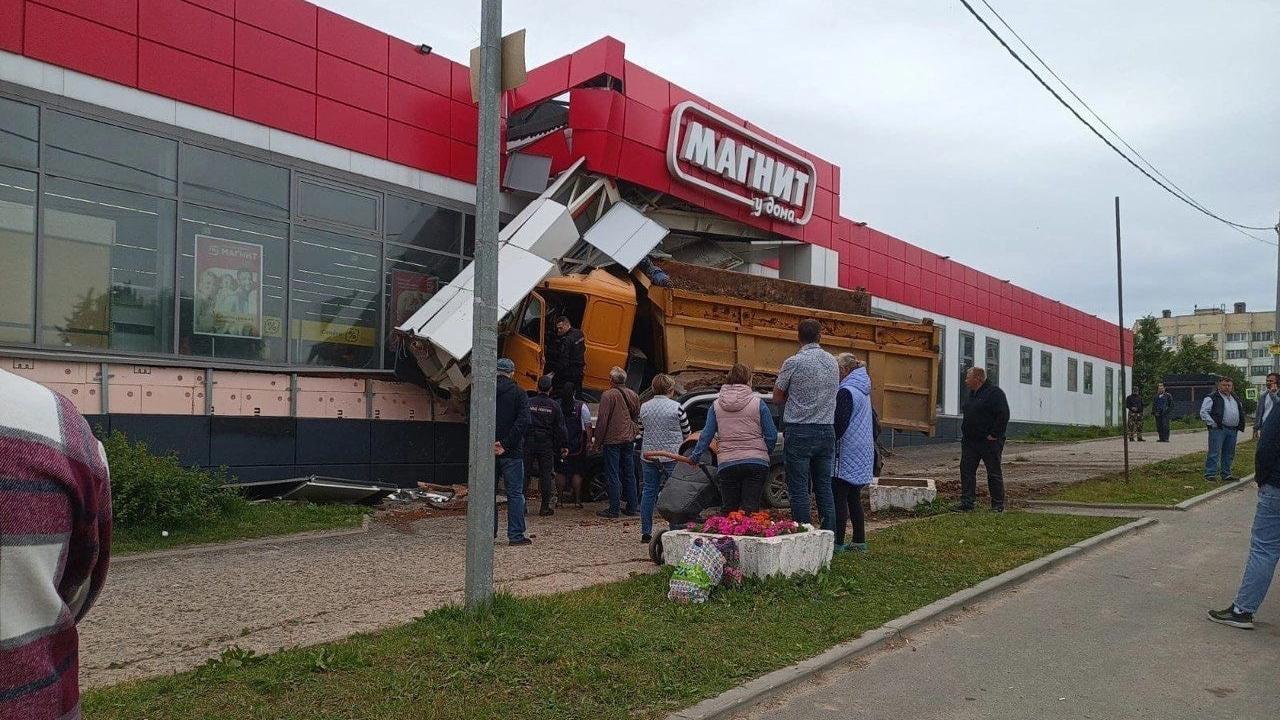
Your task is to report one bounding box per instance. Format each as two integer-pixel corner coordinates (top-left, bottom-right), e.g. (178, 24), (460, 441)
(45, 110), (178, 195)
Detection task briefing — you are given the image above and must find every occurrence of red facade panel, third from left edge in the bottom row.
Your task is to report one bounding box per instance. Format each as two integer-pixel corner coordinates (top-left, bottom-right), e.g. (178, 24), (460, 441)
(138, 40), (236, 114)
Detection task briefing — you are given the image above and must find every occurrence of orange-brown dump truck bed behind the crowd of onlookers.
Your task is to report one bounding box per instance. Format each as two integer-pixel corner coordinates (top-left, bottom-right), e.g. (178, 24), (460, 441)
(643, 261), (938, 434)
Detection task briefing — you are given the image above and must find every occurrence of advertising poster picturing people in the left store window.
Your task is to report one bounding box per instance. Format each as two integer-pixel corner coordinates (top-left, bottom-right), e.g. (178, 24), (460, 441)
(193, 234), (262, 340)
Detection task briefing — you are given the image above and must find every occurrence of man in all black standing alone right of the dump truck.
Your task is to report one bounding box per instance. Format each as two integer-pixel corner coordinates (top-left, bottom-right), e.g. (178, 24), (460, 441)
(960, 368), (1009, 512)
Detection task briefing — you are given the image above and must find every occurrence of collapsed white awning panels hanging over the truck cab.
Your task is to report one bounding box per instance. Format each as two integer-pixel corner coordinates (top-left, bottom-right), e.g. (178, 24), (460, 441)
(396, 160), (667, 391)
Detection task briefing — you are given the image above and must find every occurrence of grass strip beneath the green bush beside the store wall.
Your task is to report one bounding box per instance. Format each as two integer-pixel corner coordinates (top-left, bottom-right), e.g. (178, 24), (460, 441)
(111, 502), (369, 555)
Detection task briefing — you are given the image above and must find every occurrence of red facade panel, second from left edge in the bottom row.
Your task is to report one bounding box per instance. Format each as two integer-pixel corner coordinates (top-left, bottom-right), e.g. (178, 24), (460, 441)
(23, 3), (138, 86)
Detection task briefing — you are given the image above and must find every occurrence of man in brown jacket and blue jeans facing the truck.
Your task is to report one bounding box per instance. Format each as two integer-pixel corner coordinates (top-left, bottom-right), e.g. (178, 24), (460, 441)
(591, 368), (640, 518)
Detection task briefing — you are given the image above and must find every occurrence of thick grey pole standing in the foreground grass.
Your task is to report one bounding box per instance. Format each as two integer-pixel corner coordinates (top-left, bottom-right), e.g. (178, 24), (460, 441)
(465, 0), (502, 609)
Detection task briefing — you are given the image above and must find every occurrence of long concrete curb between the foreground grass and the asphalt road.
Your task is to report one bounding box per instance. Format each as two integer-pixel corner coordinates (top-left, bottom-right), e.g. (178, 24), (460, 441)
(667, 518), (1157, 720)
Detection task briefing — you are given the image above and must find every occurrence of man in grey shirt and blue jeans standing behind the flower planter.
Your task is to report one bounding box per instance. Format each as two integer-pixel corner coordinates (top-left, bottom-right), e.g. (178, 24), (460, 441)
(773, 318), (840, 530)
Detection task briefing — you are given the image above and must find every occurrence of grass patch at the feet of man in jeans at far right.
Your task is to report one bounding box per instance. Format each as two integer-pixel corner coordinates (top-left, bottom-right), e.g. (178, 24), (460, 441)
(1047, 441), (1254, 505)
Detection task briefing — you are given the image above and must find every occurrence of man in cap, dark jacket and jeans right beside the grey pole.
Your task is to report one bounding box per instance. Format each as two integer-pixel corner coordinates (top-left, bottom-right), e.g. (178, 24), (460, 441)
(493, 357), (534, 544)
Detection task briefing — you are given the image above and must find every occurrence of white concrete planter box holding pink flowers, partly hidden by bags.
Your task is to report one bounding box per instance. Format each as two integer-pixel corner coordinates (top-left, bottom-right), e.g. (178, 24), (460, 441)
(662, 528), (836, 578)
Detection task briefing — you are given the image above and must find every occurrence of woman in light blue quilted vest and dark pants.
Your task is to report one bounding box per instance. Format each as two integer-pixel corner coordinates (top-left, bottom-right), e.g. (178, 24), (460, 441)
(831, 352), (876, 552)
